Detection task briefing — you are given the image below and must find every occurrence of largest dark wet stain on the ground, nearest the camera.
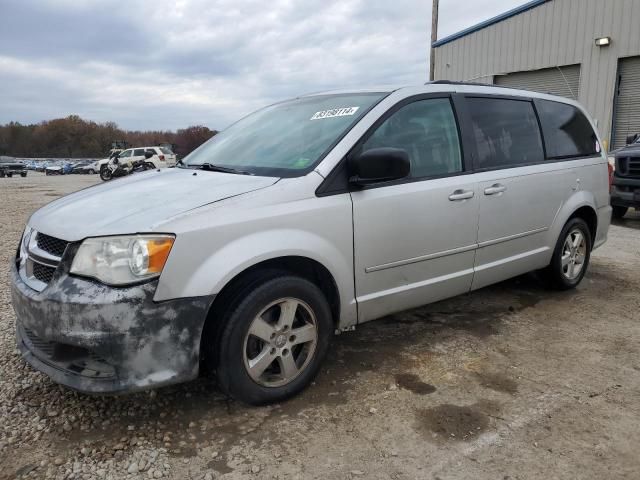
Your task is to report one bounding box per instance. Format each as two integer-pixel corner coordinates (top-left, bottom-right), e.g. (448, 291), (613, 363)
(418, 400), (498, 442)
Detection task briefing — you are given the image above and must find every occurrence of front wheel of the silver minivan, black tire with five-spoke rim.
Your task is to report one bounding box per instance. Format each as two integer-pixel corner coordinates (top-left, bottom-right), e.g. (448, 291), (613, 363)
(212, 272), (333, 405)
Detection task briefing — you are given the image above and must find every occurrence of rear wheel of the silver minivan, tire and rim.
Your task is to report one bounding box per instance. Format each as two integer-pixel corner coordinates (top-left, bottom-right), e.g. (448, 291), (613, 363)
(543, 218), (592, 290)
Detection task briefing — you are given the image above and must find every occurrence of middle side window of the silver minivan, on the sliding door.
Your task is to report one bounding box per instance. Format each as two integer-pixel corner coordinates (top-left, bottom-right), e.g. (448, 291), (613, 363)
(467, 98), (544, 168)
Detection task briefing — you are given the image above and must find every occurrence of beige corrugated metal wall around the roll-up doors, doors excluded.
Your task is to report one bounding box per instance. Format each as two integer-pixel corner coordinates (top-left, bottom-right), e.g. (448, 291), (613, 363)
(435, 0), (640, 149)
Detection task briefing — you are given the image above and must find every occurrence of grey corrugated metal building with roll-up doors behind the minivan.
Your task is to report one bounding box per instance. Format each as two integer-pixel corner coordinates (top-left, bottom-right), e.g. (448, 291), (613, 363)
(433, 0), (640, 149)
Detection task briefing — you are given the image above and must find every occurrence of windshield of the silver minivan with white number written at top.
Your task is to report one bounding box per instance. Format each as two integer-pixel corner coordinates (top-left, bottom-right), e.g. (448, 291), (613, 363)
(183, 93), (386, 177)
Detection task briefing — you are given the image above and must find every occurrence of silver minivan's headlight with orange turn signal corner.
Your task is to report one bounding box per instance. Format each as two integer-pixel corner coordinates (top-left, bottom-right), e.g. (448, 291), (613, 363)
(71, 235), (175, 285)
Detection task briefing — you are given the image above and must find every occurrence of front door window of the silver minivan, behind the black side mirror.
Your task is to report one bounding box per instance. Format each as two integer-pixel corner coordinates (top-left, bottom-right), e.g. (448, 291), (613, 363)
(362, 98), (462, 178)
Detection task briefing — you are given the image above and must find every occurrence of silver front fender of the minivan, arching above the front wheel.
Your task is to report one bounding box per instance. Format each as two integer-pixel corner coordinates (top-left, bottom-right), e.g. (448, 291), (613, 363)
(154, 186), (357, 326)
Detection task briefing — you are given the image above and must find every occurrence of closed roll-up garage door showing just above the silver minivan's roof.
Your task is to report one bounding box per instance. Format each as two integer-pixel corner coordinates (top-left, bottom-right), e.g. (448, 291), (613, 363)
(494, 64), (580, 99)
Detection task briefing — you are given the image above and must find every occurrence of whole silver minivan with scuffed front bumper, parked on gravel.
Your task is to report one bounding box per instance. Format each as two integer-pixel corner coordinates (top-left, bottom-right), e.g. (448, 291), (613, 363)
(11, 82), (611, 404)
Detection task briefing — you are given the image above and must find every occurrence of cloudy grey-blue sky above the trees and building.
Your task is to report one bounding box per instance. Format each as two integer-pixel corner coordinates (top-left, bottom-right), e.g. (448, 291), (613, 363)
(0, 0), (525, 130)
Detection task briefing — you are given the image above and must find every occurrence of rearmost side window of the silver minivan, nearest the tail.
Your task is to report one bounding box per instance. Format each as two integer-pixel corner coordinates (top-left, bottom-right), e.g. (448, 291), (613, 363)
(536, 100), (600, 159)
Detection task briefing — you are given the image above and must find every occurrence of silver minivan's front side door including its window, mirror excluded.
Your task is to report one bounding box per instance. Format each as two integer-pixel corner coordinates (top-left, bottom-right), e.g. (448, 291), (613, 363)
(351, 95), (479, 322)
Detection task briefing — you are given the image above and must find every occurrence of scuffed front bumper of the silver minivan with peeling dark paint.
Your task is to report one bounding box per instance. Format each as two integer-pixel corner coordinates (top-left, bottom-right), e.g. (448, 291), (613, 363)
(11, 263), (213, 393)
